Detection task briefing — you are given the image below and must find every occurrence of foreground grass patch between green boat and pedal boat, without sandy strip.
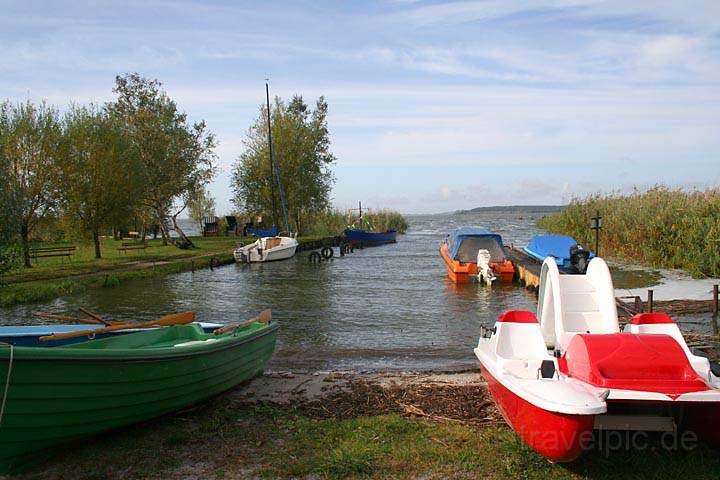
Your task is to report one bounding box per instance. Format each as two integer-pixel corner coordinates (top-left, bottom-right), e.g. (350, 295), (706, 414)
(18, 397), (720, 480)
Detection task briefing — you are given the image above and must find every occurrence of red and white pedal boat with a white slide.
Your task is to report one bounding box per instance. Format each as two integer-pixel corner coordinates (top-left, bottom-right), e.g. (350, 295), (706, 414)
(475, 258), (720, 462)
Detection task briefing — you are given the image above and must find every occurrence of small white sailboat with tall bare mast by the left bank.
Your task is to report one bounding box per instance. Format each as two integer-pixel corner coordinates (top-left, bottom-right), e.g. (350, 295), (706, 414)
(233, 83), (298, 263)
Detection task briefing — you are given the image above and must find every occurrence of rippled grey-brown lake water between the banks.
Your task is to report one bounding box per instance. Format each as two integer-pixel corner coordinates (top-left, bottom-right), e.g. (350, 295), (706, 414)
(0, 209), (556, 371)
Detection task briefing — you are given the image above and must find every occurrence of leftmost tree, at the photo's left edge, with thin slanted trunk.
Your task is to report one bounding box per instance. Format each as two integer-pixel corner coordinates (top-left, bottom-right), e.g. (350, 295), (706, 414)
(0, 101), (62, 268)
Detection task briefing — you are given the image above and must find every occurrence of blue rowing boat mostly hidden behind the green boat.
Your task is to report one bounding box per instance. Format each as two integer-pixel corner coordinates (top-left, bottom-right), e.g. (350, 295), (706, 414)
(0, 322), (222, 347)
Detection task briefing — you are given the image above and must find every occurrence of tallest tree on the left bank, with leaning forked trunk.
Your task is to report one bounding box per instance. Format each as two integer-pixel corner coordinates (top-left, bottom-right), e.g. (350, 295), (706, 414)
(107, 73), (216, 251)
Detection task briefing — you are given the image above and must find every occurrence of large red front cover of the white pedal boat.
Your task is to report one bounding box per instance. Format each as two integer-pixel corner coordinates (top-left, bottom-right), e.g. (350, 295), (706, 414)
(558, 333), (709, 395)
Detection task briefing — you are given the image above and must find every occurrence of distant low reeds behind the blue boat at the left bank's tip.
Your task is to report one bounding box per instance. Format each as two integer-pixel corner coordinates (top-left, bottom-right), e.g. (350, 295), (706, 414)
(302, 209), (408, 236)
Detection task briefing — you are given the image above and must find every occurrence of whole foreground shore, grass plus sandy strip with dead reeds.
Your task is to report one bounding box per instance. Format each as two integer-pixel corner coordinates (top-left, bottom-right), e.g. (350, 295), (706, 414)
(12, 370), (720, 480)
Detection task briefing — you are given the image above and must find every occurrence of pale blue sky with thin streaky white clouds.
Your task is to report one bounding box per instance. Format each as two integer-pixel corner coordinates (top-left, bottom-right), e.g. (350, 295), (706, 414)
(0, 0), (720, 214)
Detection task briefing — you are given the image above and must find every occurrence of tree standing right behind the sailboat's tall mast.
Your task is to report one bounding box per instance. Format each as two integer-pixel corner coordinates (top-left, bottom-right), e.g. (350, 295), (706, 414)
(233, 96), (335, 232)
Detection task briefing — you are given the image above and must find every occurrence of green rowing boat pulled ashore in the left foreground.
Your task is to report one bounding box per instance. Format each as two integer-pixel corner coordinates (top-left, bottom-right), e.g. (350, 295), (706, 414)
(0, 323), (277, 472)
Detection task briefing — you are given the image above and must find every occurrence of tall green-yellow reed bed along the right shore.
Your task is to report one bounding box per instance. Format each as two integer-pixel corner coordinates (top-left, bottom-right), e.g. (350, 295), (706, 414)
(538, 186), (720, 278)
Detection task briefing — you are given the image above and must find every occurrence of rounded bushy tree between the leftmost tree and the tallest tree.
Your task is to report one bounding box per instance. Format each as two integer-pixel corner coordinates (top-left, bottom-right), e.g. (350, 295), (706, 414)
(59, 105), (140, 258)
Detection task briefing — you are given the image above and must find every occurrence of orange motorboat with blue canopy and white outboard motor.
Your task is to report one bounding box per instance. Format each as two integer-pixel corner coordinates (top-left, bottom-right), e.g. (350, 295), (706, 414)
(440, 227), (515, 284)
